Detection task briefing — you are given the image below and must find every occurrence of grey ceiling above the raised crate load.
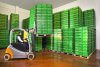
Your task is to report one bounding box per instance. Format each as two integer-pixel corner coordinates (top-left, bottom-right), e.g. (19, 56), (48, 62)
(0, 0), (76, 10)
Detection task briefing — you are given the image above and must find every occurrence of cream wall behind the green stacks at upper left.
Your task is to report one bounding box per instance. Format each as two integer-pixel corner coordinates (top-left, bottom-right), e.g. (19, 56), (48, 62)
(0, 2), (29, 28)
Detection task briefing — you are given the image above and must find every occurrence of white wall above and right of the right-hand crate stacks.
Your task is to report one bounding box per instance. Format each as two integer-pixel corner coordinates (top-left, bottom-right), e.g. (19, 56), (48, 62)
(53, 0), (100, 50)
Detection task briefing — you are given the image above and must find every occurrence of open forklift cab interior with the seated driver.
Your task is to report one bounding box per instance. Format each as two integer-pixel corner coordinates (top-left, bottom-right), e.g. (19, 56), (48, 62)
(11, 29), (29, 52)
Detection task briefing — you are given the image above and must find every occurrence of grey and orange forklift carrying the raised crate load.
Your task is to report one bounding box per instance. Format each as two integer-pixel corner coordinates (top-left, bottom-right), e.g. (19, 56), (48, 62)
(4, 28), (35, 61)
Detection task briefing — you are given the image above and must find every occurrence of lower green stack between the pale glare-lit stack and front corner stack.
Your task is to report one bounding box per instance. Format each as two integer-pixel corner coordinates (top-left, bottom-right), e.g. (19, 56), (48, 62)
(62, 28), (74, 54)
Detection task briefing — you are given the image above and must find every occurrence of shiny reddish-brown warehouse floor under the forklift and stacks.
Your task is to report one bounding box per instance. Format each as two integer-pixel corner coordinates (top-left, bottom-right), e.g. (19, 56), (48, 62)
(0, 50), (100, 67)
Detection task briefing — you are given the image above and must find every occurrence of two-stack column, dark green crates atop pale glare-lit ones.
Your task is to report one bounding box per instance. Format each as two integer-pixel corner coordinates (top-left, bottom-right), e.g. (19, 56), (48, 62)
(53, 12), (62, 52)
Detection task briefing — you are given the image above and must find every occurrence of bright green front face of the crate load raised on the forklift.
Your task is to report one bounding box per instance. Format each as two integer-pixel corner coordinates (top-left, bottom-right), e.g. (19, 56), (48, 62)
(36, 4), (53, 34)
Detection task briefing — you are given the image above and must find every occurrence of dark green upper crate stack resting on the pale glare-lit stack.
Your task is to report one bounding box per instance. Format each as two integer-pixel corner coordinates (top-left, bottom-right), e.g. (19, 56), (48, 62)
(53, 12), (61, 29)
